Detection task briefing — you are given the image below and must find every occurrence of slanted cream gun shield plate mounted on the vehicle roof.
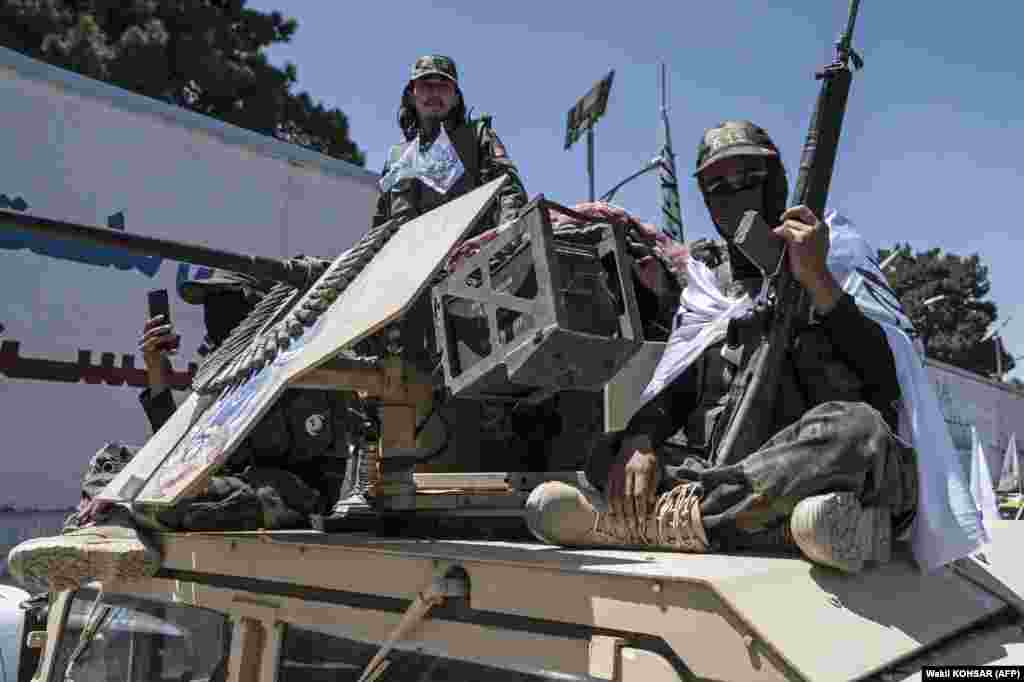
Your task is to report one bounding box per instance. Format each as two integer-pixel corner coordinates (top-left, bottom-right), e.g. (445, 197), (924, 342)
(100, 176), (507, 505)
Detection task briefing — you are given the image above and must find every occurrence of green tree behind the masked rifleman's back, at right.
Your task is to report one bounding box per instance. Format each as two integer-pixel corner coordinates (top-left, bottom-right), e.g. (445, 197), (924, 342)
(879, 244), (1015, 376)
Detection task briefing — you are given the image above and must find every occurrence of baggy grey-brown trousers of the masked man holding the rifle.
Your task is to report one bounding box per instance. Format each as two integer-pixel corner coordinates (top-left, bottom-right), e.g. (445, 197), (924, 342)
(587, 402), (918, 551)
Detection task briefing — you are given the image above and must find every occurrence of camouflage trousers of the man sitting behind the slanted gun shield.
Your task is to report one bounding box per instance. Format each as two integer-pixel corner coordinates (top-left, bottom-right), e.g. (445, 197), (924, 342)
(65, 443), (326, 531)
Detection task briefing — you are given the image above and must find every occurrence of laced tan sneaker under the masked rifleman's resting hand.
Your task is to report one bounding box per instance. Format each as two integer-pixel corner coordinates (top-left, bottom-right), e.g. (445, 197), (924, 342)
(526, 481), (709, 552)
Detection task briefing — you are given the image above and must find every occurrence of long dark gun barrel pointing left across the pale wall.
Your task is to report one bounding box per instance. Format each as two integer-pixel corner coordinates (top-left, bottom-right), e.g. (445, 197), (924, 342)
(0, 204), (308, 287)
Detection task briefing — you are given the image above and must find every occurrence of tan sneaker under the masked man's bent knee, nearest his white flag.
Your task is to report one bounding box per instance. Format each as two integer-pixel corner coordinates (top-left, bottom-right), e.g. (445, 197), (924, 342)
(790, 493), (892, 573)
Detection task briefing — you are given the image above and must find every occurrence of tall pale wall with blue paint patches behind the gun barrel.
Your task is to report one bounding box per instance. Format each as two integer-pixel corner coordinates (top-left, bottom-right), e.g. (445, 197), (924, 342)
(0, 48), (377, 508)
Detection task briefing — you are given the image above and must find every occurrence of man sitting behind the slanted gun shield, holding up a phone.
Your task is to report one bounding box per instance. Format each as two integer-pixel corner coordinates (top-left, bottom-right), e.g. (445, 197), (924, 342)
(7, 270), (344, 591)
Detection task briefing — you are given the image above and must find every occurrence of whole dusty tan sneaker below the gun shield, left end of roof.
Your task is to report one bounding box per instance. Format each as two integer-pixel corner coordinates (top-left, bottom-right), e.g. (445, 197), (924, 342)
(7, 507), (160, 592)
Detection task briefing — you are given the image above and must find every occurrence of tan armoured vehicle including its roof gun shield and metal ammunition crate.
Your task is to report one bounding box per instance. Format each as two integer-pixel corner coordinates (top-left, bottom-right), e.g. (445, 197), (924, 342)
(8, 119), (1024, 682)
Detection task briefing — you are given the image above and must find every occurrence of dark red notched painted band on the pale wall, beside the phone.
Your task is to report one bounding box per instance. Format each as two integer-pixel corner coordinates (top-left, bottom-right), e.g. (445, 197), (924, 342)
(0, 341), (196, 390)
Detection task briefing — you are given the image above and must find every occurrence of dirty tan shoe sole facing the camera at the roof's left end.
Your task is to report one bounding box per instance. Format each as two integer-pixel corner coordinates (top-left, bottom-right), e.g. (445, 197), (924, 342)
(8, 537), (160, 590)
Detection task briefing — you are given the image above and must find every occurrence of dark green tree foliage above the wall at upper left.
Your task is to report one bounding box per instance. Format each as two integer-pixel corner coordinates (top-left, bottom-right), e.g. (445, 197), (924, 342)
(0, 0), (365, 166)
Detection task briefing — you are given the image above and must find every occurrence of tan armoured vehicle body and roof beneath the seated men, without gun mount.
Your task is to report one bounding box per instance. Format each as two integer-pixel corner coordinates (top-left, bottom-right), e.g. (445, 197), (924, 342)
(14, 521), (1024, 682)
